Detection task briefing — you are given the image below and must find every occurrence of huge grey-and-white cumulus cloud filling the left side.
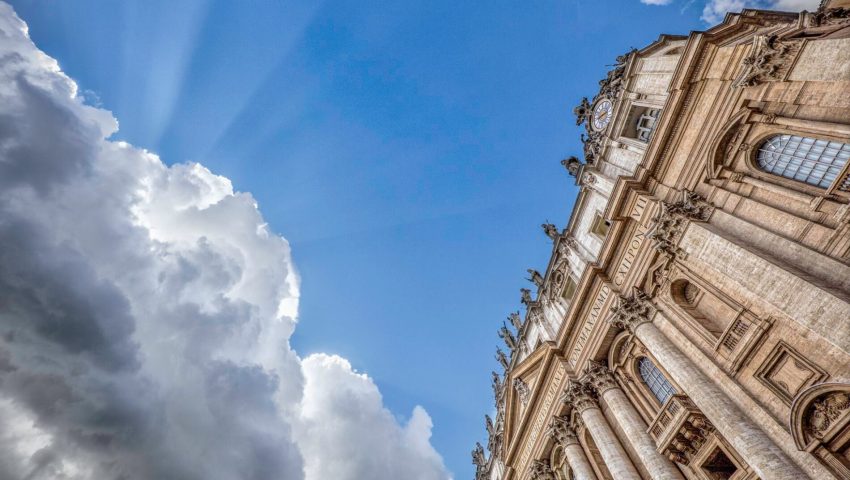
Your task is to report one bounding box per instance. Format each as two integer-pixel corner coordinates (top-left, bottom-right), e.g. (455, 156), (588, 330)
(0, 2), (448, 480)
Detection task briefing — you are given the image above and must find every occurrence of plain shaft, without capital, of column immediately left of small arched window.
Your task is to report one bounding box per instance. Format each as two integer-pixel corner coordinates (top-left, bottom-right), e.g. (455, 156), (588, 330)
(602, 387), (684, 480)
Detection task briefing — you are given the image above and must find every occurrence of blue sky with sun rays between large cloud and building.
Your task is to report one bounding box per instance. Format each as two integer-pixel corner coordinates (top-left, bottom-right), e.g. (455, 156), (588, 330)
(6, 0), (704, 478)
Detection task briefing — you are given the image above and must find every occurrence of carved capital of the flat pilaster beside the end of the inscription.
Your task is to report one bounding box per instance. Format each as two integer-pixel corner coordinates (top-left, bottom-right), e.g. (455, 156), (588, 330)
(647, 190), (714, 259)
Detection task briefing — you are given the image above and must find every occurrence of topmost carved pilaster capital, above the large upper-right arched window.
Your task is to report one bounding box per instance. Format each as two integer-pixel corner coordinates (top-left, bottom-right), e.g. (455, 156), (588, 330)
(732, 35), (802, 88)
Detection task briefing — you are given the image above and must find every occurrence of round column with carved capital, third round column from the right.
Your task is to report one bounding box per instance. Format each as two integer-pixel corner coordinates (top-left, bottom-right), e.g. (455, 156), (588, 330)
(564, 382), (641, 480)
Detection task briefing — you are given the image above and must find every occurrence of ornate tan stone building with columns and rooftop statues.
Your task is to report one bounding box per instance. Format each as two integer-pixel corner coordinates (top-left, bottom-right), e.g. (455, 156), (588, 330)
(473, 0), (850, 480)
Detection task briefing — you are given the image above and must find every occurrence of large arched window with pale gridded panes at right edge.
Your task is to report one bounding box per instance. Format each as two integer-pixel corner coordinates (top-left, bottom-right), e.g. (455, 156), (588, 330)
(758, 135), (850, 189)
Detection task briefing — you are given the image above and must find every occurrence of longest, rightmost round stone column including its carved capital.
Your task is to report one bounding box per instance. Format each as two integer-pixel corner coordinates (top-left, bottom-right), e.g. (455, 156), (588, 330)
(608, 292), (807, 480)
